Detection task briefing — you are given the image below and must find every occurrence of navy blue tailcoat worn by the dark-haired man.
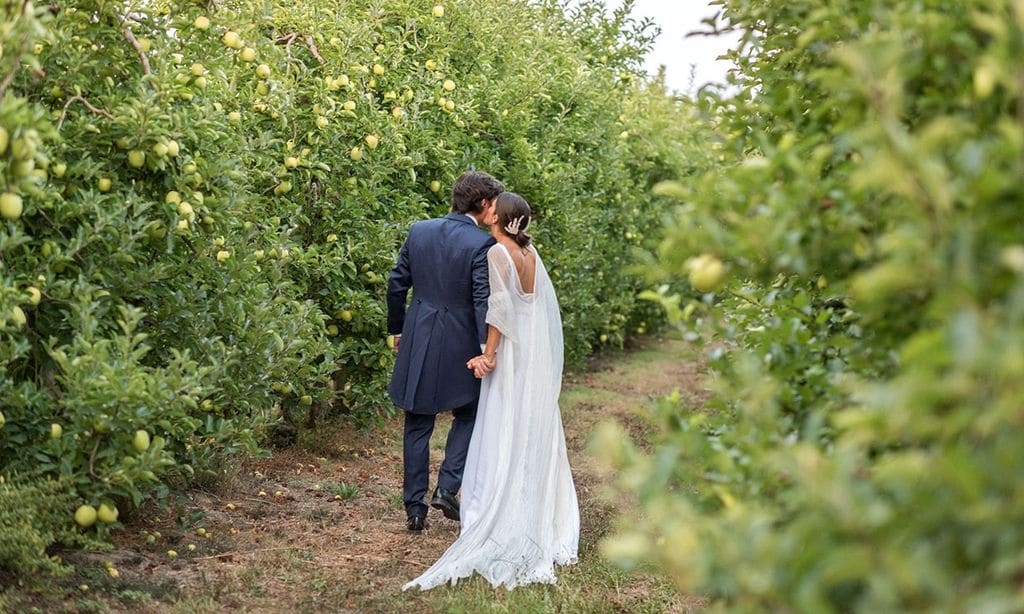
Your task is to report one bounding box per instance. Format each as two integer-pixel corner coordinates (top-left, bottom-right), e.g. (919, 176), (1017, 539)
(387, 213), (495, 413)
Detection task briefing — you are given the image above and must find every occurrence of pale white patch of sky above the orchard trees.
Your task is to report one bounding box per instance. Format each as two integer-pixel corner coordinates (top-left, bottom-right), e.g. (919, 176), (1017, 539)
(605, 0), (738, 92)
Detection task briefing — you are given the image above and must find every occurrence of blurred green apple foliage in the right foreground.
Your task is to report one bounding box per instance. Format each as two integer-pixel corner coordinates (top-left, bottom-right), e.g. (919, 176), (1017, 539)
(596, 0), (1024, 612)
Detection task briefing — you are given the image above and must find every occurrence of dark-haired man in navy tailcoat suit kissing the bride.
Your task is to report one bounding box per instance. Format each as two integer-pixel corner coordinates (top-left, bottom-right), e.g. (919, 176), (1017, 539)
(387, 171), (505, 531)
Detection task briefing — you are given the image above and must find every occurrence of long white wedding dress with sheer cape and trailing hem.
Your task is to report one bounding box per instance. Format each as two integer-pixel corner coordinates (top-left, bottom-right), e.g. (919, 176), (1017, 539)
(402, 244), (580, 590)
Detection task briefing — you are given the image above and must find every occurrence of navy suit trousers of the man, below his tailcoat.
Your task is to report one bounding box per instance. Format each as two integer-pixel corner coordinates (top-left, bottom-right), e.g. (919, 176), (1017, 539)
(401, 399), (477, 516)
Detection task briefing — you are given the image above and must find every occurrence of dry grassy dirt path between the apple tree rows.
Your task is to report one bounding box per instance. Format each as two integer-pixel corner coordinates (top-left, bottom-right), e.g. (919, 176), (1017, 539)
(32, 340), (702, 613)
